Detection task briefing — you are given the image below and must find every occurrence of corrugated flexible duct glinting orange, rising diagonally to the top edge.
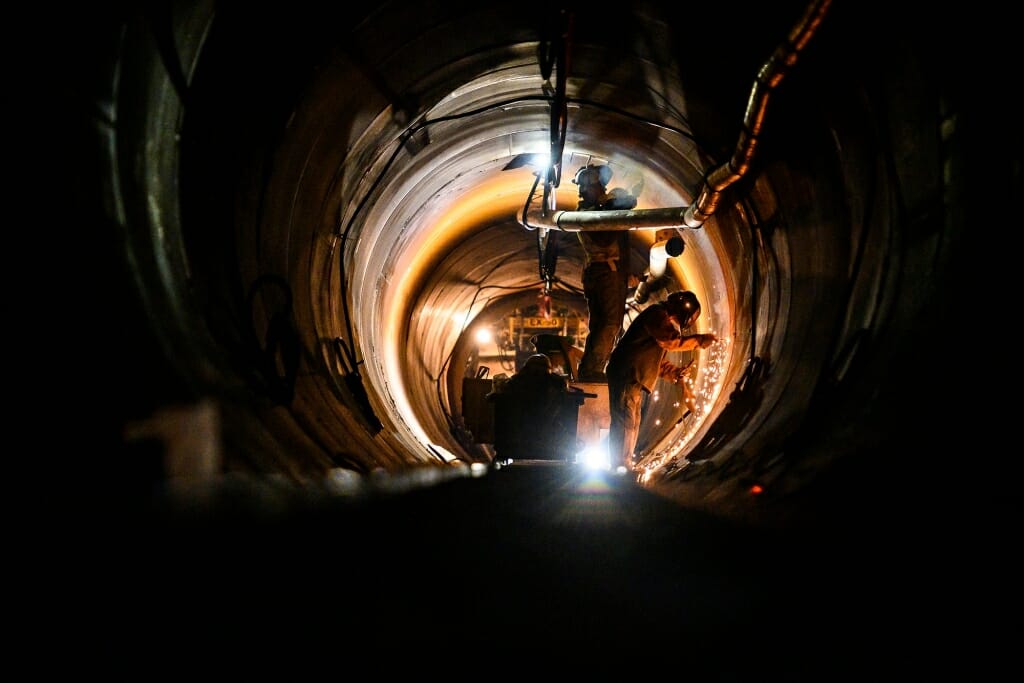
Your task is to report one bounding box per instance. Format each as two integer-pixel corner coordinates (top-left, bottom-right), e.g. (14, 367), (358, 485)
(683, 0), (831, 228)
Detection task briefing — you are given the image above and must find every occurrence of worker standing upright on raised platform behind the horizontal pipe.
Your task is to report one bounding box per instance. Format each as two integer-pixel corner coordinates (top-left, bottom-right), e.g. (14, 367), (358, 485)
(572, 164), (637, 382)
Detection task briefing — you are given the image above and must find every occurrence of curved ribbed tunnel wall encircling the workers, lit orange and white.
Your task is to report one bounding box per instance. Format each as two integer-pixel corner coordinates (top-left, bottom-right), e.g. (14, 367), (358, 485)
(75, 2), (1003, 522)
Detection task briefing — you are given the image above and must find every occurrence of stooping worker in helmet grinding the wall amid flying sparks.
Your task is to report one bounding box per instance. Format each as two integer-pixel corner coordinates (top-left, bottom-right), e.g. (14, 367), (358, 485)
(607, 291), (717, 471)
